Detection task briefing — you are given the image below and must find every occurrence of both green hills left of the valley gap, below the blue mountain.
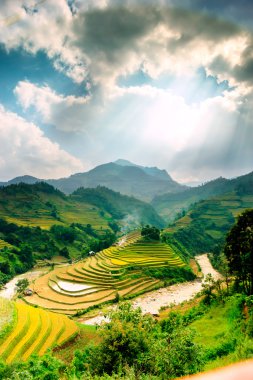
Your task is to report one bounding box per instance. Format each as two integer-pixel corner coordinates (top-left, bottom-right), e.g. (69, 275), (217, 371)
(0, 182), (164, 230)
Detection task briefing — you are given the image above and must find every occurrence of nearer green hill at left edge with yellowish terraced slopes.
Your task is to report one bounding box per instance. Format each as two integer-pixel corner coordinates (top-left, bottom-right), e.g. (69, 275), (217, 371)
(0, 182), (110, 229)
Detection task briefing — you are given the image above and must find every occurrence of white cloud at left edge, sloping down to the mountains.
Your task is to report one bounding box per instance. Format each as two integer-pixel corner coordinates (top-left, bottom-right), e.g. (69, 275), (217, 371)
(0, 105), (83, 180)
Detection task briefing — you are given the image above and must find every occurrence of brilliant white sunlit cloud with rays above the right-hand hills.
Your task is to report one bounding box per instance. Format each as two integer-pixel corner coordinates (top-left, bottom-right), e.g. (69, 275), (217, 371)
(89, 86), (253, 182)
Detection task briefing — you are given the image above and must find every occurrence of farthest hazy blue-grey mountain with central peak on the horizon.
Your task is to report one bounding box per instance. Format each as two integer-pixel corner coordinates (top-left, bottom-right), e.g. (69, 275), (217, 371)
(0, 160), (186, 201)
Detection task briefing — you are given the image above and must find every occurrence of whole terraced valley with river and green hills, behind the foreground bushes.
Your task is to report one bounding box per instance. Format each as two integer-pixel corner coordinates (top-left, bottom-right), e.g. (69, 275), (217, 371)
(0, 168), (253, 379)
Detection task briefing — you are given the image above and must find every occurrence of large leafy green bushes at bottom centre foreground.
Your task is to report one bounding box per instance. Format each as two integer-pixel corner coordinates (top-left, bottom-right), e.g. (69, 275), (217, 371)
(70, 303), (203, 379)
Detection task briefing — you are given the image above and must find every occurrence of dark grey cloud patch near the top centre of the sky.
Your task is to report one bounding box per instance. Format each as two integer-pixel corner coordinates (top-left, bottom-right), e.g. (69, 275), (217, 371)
(74, 7), (159, 62)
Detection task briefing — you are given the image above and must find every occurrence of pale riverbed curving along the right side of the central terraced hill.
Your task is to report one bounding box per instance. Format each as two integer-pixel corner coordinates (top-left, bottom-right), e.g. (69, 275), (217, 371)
(82, 254), (221, 325)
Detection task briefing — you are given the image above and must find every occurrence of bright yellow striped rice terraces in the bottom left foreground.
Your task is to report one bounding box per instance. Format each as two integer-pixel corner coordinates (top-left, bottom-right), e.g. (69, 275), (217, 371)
(0, 299), (78, 364)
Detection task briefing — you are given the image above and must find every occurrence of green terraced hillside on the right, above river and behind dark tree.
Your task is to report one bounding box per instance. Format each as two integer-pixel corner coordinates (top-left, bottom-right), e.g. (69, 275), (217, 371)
(165, 184), (253, 255)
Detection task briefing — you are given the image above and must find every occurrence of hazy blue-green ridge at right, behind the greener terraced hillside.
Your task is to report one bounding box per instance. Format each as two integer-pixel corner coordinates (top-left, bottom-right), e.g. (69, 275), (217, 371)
(151, 172), (253, 221)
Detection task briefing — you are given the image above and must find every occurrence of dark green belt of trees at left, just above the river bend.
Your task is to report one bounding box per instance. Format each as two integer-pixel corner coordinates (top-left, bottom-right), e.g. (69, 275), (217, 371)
(0, 219), (116, 285)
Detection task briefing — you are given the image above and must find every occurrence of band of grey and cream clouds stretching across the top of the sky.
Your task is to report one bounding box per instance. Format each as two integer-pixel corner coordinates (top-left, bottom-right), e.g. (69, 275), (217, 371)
(0, 0), (252, 90)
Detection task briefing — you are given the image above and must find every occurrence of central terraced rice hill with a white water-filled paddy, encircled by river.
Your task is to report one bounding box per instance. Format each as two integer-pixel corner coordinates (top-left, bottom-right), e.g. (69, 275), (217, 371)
(23, 231), (185, 314)
